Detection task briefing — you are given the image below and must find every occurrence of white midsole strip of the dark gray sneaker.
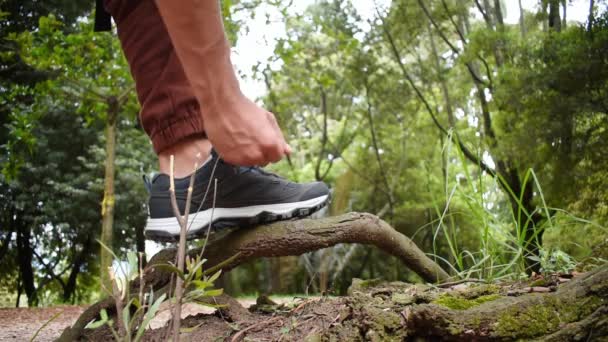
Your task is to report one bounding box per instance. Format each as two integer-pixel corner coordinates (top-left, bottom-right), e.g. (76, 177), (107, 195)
(145, 195), (328, 235)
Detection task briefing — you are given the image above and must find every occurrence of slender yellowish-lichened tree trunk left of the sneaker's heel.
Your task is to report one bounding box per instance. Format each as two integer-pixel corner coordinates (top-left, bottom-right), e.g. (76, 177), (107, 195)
(100, 97), (119, 290)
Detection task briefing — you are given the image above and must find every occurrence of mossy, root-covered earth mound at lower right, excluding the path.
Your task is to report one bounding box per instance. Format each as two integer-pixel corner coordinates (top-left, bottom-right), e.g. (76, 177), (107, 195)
(190, 265), (608, 342)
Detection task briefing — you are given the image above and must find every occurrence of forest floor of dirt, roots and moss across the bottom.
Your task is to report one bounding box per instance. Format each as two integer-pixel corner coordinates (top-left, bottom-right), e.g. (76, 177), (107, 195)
(0, 268), (608, 342)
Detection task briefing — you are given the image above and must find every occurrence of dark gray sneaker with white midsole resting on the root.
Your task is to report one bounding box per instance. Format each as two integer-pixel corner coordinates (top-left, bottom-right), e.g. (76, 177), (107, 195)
(144, 151), (329, 241)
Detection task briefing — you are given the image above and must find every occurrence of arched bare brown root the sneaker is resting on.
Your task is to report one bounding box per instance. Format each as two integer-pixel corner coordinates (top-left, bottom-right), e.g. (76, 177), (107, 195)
(59, 213), (449, 341)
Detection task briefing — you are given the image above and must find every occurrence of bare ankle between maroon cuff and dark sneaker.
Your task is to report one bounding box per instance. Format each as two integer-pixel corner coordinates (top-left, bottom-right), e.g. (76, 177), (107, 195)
(158, 138), (211, 178)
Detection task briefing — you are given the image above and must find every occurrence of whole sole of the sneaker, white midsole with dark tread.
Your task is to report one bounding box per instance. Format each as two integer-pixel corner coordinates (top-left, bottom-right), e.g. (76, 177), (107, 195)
(144, 195), (329, 242)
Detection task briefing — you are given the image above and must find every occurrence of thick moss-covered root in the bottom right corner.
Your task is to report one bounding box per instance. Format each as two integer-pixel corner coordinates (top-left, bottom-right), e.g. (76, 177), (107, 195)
(406, 265), (608, 341)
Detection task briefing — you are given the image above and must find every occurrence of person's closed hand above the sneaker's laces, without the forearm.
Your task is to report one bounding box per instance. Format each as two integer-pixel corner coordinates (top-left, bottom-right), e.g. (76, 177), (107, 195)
(202, 94), (291, 166)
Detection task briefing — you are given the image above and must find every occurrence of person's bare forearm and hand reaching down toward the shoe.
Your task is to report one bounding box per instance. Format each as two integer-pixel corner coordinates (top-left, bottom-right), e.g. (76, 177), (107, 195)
(156, 0), (291, 165)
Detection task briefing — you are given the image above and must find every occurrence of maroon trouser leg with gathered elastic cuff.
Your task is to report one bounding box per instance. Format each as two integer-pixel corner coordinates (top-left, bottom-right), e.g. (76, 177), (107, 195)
(105, 0), (205, 154)
